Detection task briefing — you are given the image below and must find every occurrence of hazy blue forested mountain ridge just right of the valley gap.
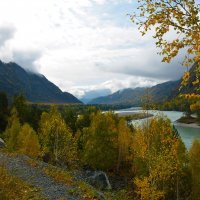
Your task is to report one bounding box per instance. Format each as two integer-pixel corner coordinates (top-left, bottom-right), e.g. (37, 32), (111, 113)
(89, 81), (179, 106)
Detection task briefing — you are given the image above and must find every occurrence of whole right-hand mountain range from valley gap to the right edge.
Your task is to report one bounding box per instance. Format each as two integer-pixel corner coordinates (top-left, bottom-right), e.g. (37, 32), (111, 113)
(89, 63), (200, 106)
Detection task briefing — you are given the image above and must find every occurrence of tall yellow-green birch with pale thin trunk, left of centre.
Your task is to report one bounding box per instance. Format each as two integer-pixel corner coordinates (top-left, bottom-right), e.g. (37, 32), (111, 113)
(39, 106), (75, 164)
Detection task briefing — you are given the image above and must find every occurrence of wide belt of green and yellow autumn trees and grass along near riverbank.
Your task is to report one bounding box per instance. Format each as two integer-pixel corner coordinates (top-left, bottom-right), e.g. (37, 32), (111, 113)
(0, 95), (200, 200)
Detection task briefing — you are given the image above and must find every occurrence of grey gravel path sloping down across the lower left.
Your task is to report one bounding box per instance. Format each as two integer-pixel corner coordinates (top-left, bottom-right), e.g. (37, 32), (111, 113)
(0, 152), (79, 200)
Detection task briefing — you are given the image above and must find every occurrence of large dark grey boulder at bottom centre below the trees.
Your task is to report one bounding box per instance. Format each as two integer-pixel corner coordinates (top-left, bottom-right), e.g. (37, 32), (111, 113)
(86, 171), (112, 190)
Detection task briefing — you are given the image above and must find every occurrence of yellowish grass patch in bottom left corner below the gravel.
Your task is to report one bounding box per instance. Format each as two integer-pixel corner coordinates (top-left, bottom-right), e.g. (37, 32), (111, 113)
(0, 166), (44, 200)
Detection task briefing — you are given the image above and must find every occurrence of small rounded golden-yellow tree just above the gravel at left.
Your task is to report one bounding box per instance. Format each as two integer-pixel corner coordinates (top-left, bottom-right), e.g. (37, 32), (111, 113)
(18, 124), (40, 158)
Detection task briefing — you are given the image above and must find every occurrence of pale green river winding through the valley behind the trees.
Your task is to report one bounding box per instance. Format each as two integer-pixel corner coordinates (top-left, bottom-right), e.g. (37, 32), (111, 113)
(115, 107), (200, 149)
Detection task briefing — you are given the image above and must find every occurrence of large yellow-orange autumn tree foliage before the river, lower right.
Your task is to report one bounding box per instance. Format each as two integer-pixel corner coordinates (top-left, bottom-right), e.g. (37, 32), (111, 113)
(133, 117), (189, 200)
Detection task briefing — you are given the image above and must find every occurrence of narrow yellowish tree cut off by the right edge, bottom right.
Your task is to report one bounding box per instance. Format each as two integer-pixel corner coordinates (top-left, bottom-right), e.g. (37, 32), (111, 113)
(190, 139), (200, 200)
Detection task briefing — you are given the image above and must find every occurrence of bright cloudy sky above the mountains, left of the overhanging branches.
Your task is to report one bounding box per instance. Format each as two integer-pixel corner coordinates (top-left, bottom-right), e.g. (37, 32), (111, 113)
(0, 0), (184, 97)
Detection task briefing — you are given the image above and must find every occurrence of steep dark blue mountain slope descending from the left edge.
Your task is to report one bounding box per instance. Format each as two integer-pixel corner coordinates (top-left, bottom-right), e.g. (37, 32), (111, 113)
(0, 61), (82, 104)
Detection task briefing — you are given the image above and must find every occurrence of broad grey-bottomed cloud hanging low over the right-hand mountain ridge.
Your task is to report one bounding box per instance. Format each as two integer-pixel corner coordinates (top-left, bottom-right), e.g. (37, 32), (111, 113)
(97, 46), (185, 80)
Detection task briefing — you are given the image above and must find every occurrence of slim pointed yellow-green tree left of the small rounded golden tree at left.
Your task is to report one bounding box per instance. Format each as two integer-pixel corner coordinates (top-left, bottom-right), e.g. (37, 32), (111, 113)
(4, 108), (21, 151)
